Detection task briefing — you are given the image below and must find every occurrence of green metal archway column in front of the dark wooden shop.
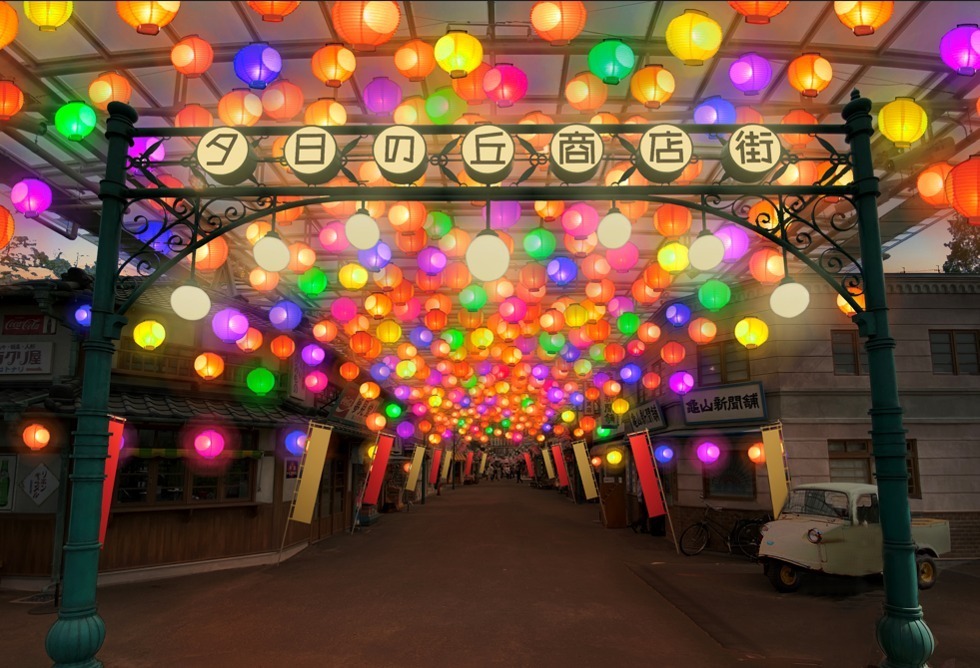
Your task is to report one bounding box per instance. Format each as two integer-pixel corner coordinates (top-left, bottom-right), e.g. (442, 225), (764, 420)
(44, 102), (137, 667)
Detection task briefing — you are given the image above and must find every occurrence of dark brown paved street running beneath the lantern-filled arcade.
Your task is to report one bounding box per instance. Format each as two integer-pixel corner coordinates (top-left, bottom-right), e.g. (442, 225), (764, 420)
(0, 481), (980, 668)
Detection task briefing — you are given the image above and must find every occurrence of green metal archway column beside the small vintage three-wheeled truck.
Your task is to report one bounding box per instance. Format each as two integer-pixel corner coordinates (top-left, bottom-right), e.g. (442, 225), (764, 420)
(843, 90), (935, 668)
